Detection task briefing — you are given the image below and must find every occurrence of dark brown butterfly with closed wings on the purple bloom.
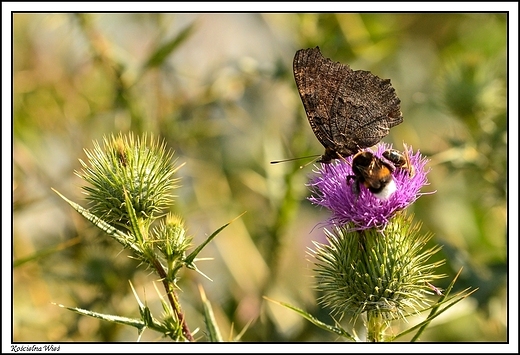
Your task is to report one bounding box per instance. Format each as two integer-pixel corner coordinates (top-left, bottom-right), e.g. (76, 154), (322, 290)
(293, 47), (403, 163)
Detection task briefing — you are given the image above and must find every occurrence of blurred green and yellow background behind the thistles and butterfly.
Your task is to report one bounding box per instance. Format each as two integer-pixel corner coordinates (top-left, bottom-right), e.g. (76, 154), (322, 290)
(13, 13), (507, 342)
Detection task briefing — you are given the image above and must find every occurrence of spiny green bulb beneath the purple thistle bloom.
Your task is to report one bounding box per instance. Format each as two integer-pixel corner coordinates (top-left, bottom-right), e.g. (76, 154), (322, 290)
(311, 214), (444, 320)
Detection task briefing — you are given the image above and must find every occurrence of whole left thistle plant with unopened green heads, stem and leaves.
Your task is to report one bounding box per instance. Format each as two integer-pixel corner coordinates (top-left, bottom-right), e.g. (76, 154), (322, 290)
(51, 134), (235, 341)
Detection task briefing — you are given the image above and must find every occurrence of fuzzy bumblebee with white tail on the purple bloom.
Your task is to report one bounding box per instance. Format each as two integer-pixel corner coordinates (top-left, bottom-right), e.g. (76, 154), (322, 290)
(347, 151), (397, 200)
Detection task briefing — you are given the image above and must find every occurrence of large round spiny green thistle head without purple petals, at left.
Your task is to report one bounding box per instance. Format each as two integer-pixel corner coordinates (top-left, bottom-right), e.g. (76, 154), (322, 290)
(76, 134), (179, 228)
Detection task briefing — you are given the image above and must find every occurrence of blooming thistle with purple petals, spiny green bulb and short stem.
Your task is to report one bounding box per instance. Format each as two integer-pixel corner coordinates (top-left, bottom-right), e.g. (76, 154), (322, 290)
(309, 144), (444, 341)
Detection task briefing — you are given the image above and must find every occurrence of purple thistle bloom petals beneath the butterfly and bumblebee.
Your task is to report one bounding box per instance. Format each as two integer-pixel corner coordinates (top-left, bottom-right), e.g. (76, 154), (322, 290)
(308, 143), (430, 230)
